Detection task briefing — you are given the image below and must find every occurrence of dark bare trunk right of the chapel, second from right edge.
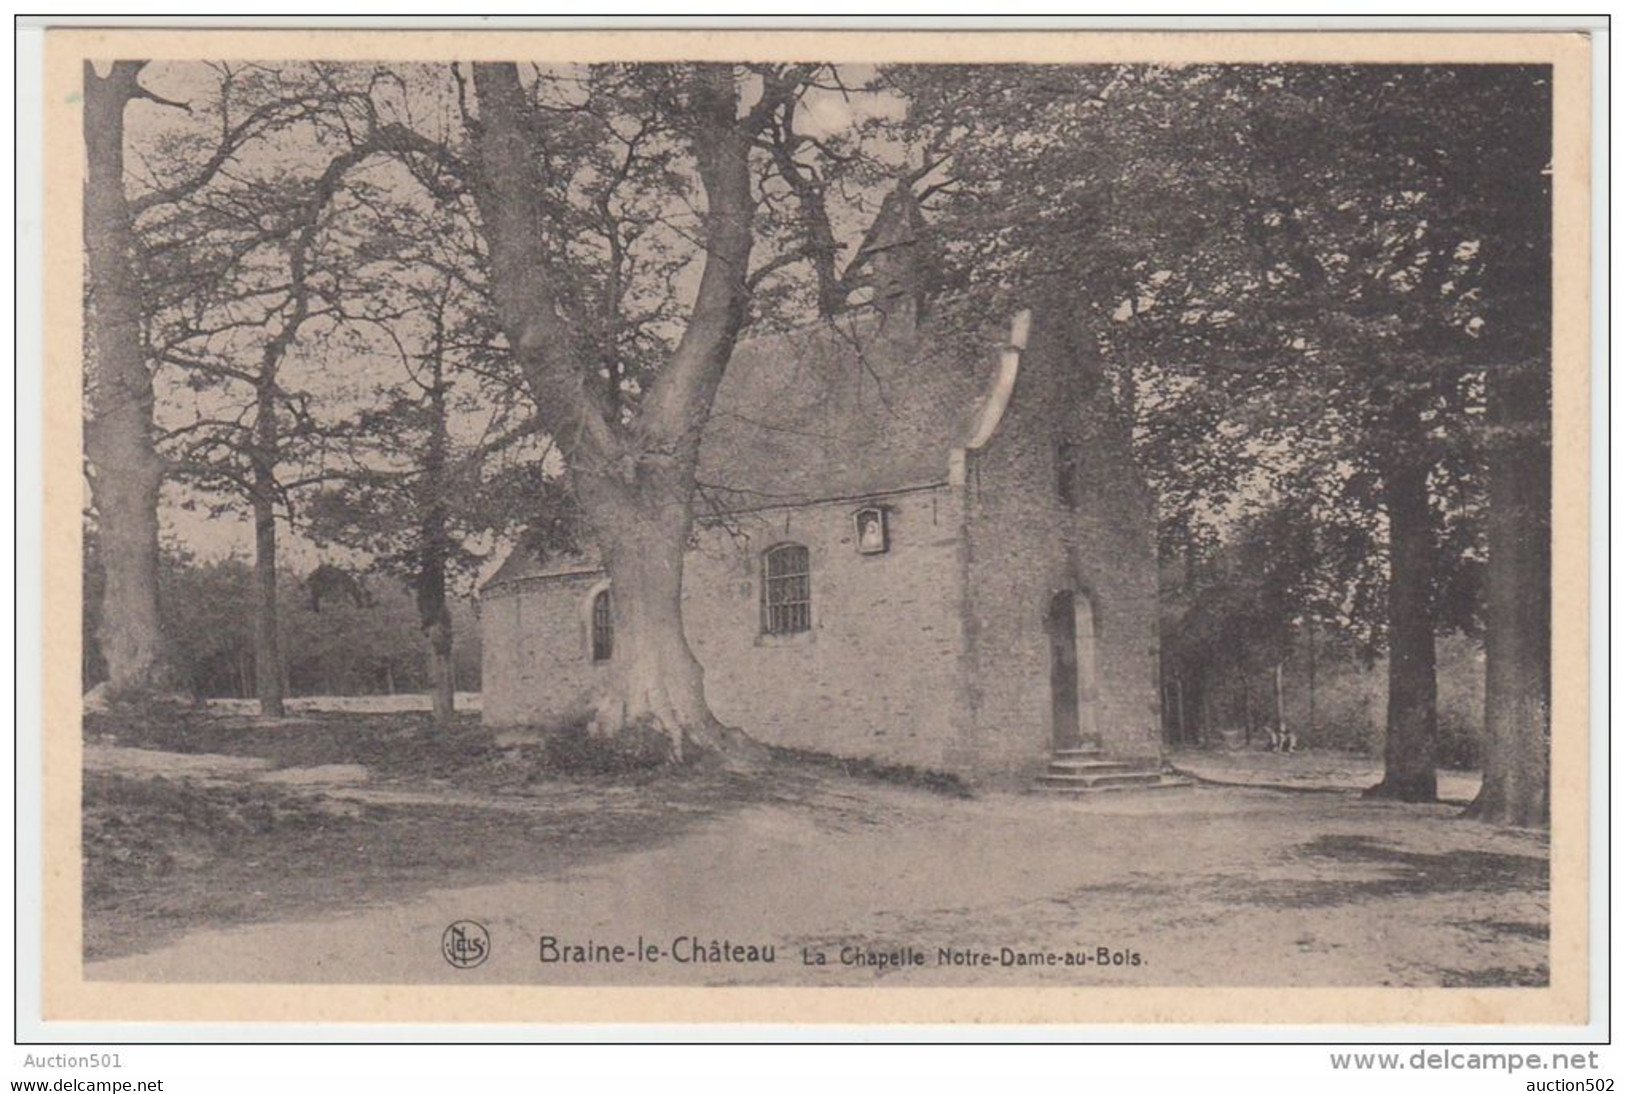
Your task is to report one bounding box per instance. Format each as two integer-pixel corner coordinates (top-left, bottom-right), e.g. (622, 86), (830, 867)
(1367, 444), (1438, 801)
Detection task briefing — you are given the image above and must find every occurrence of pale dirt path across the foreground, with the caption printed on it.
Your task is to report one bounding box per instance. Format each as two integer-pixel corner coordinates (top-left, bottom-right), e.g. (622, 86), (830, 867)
(86, 779), (1547, 985)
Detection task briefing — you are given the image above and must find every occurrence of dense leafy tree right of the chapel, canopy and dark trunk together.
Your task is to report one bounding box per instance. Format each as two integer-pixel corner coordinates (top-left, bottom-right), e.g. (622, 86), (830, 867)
(897, 65), (1542, 800)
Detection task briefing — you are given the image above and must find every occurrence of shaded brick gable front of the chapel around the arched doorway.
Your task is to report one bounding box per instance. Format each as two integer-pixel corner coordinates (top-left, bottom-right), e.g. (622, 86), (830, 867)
(949, 307), (1160, 775)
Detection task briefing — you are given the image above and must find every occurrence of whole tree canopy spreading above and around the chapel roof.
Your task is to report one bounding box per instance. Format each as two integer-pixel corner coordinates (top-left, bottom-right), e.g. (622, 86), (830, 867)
(98, 63), (1550, 786)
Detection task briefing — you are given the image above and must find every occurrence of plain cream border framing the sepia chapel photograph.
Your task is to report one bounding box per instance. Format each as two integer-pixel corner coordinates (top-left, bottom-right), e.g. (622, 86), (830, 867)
(31, 28), (1591, 1026)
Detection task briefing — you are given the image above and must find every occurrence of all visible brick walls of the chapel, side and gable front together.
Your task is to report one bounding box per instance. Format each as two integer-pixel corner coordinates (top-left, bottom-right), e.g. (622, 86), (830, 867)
(483, 308), (1160, 779)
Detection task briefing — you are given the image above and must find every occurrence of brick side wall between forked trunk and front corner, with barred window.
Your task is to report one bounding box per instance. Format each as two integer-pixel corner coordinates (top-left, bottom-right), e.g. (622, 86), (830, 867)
(683, 488), (964, 769)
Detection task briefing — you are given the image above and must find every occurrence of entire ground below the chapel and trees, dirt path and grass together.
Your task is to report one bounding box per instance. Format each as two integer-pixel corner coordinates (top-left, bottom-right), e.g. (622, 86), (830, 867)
(85, 712), (1549, 987)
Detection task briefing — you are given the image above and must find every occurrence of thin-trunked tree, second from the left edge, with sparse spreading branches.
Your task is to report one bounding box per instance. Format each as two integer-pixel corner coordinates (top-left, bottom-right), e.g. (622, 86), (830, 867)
(156, 76), (416, 717)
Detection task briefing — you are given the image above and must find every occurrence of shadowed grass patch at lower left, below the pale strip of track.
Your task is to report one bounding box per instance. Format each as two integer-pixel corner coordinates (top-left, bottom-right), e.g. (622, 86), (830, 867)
(83, 772), (765, 959)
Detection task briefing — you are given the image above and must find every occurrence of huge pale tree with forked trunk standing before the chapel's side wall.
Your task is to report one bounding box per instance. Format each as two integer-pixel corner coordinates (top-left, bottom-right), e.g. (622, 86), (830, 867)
(473, 63), (851, 759)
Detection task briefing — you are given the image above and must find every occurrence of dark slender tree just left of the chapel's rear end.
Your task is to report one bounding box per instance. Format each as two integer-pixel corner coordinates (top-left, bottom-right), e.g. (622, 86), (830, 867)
(304, 250), (574, 727)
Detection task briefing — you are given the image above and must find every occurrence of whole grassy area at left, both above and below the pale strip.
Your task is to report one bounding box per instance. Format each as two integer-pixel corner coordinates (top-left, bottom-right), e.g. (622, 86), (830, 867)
(83, 707), (786, 959)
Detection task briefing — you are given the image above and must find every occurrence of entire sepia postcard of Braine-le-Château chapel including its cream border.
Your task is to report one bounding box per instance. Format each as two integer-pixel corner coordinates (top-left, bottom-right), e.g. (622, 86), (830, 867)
(31, 29), (1597, 1026)
